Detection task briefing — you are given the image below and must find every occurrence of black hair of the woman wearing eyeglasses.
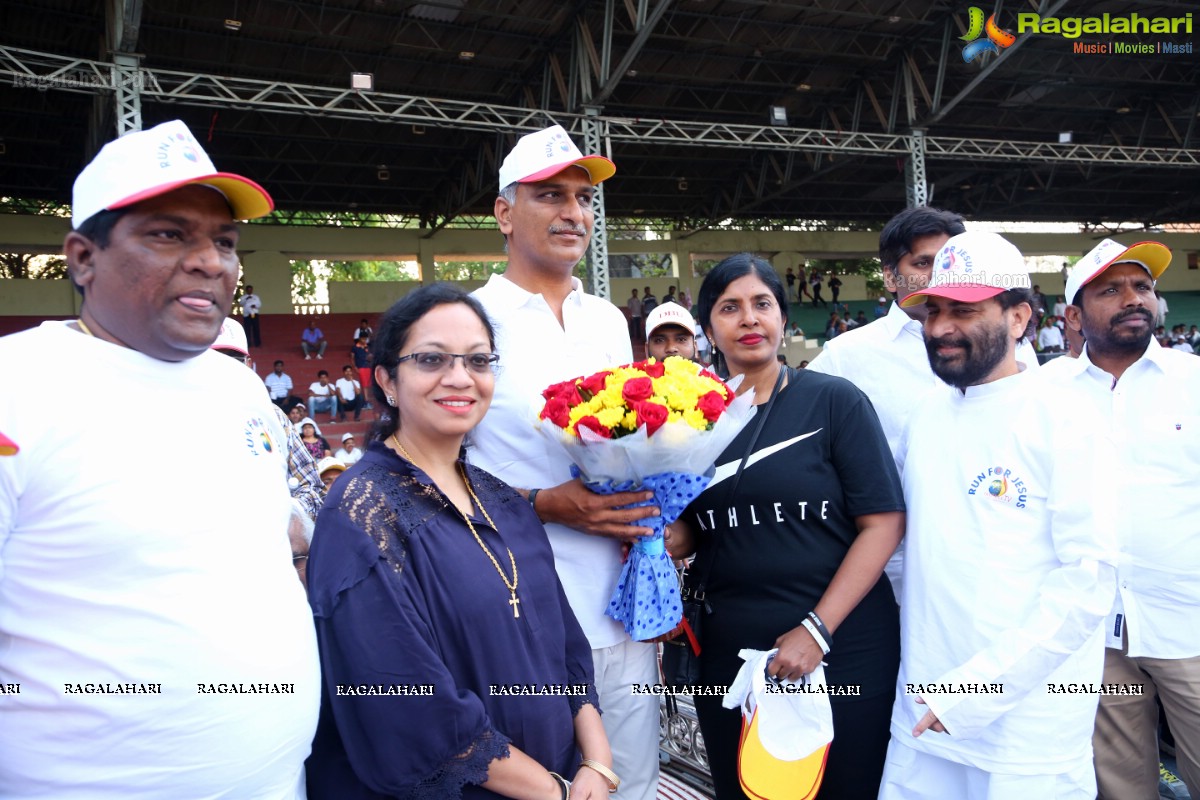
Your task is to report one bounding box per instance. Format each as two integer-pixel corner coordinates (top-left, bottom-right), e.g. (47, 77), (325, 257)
(367, 283), (496, 441)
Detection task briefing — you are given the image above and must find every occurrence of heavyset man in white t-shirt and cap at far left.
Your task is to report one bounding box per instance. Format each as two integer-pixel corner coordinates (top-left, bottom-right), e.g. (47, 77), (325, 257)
(0, 121), (319, 800)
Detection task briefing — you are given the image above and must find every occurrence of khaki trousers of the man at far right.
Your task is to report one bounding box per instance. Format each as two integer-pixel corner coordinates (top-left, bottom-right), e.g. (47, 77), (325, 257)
(1092, 638), (1200, 800)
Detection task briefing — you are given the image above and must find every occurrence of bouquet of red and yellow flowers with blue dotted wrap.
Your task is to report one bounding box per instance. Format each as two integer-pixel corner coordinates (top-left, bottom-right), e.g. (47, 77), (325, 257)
(538, 356), (755, 640)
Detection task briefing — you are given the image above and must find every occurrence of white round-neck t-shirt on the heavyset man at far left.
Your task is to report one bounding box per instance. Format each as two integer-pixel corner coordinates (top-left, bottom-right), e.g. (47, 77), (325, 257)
(0, 321), (319, 800)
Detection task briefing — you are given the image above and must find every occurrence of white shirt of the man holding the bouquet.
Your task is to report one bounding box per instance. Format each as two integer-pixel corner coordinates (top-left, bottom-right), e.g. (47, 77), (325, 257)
(468, 275), (634, 649)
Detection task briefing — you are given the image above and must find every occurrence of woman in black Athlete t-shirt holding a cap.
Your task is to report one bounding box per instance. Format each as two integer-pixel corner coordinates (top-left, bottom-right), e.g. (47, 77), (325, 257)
(668, 253), (905, 800)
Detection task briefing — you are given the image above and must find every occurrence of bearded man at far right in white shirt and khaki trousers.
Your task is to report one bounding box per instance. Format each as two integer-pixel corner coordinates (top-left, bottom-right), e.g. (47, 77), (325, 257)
(1055, 239), (1200, 800)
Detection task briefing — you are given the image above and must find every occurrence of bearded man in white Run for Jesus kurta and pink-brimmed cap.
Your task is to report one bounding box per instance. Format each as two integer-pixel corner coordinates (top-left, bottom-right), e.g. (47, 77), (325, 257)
(880, 233), (1115, 800)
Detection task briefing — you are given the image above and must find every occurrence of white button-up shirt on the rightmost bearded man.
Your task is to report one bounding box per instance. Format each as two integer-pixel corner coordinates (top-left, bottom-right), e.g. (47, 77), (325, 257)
(1054, 341), (1200, 658)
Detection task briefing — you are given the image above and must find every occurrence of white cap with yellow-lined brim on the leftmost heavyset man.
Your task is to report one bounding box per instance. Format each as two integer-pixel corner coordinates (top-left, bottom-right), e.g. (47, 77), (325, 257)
(71, 120), (275, 228)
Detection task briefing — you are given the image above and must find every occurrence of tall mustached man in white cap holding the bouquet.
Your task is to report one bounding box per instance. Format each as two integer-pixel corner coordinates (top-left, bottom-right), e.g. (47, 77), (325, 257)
(469, 125), (659, 800)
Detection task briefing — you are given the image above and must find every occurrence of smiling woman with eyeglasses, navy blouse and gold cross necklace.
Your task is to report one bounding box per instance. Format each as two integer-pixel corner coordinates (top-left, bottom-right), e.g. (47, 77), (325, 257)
(307, 284), (618, 800)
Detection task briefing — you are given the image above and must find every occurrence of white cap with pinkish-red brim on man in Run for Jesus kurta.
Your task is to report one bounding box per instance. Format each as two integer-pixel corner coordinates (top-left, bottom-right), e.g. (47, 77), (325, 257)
(900, 230), (1033, 307)
